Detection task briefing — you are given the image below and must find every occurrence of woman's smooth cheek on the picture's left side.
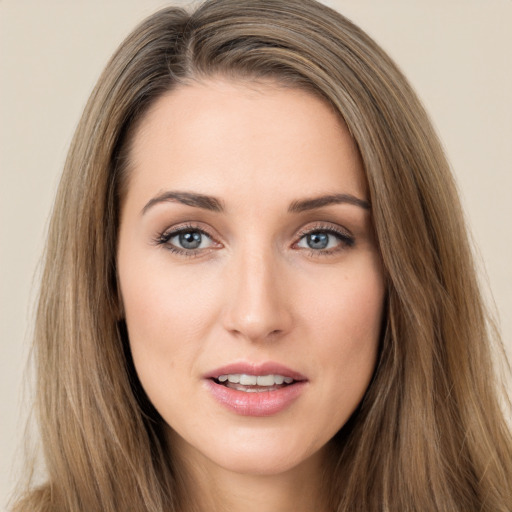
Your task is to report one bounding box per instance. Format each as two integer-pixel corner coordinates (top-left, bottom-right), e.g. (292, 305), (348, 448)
(119, 248), (222, 394)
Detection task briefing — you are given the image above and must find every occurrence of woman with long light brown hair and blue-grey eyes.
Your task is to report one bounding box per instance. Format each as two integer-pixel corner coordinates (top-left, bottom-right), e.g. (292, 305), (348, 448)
(11, 0), (512, 511)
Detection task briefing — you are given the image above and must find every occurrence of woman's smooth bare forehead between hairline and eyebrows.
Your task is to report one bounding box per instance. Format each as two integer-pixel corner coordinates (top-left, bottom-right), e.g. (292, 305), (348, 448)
(128, 80), (366, 207)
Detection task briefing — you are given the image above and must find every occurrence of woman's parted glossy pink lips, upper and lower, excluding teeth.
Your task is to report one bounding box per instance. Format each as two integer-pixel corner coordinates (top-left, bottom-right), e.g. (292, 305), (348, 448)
(204, 362), (308, 417)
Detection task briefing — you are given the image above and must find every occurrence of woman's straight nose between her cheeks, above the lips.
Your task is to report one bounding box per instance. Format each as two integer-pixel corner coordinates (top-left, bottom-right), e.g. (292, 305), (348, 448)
(223, 251), (293, 342)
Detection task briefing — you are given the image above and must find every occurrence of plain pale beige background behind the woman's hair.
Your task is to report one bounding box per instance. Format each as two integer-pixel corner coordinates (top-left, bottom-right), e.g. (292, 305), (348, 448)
(0, 0), (512, 508)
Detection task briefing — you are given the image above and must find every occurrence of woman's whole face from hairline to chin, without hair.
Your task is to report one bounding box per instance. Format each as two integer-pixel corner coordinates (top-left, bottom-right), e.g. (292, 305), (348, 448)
(118, 80), (384, 475)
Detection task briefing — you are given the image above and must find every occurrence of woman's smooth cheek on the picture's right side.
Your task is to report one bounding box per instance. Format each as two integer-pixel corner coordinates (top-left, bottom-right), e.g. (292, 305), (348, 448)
(296, 262), (385, 418)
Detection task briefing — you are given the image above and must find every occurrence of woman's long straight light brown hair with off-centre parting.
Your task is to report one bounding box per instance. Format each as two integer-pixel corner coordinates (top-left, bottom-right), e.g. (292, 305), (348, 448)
(14, 0), (512, 512)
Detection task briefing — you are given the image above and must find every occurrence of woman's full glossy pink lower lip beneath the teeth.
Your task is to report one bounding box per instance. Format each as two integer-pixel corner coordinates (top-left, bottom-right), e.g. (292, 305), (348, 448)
(206, 379), (306, 416)
